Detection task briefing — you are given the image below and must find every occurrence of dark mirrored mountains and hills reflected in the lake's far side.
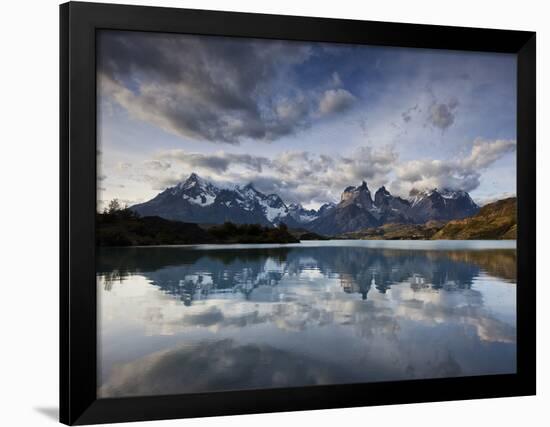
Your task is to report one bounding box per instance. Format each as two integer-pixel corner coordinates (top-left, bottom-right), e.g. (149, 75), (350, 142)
(98, 247), (516, 305)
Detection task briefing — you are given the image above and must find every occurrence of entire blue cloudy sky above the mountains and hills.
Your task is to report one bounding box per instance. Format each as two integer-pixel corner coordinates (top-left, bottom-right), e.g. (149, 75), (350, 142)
(98, 31), (516, 211)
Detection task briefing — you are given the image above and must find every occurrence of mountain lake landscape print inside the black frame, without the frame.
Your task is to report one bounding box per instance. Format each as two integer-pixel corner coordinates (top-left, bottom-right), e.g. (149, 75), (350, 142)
(96, 30), (517, 398)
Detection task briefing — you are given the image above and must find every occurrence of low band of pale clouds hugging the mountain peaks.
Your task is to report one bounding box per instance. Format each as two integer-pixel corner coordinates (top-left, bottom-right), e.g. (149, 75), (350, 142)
(109, 139), (516, 206)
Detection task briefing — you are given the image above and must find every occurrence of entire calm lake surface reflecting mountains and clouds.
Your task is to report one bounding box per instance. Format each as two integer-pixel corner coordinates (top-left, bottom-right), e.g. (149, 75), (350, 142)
(97, 241), (516, 397)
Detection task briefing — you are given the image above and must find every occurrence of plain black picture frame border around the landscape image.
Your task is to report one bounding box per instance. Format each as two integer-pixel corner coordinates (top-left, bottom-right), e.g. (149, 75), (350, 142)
(60, 2), (536, 425)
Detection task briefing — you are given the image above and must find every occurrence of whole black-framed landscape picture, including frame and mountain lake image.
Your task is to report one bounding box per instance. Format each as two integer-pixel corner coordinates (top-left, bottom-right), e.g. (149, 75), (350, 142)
(60, 2), (535, 424)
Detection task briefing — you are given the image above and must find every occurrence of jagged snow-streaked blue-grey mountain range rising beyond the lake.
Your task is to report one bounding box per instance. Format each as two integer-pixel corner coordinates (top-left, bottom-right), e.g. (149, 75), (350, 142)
(130, 173), (479, 235)
